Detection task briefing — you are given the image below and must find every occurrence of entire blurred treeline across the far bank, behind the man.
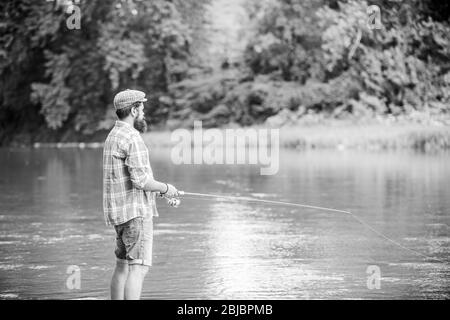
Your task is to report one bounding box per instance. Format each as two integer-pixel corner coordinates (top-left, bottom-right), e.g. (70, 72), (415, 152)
(0, 0), (450, 144)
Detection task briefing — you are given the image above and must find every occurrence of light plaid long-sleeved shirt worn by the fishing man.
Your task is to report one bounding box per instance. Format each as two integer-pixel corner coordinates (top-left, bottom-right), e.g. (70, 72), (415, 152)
(103, 121), (158, 225)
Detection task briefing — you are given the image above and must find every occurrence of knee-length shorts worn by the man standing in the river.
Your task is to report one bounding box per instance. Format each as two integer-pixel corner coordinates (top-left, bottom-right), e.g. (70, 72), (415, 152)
(114, 217), (153, 266)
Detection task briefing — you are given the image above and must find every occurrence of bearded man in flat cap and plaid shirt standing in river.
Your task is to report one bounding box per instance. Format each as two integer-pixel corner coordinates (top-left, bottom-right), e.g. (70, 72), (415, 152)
(103, 90), (178, 300)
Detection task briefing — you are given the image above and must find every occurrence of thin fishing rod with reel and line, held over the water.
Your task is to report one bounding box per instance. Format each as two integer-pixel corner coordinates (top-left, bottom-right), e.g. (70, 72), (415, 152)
(160, 191), (448, 264)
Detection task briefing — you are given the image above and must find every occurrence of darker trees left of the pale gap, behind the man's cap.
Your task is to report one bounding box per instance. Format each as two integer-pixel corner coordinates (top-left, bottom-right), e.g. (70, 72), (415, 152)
(0, 0), (208, 144)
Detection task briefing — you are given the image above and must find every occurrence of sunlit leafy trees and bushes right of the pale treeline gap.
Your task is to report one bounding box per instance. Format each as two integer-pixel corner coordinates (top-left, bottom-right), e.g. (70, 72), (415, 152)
(170, 0), (450, 127)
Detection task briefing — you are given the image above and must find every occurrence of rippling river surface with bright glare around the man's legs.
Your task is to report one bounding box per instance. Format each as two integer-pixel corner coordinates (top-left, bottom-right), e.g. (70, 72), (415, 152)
(0, 149), (450, 299)
